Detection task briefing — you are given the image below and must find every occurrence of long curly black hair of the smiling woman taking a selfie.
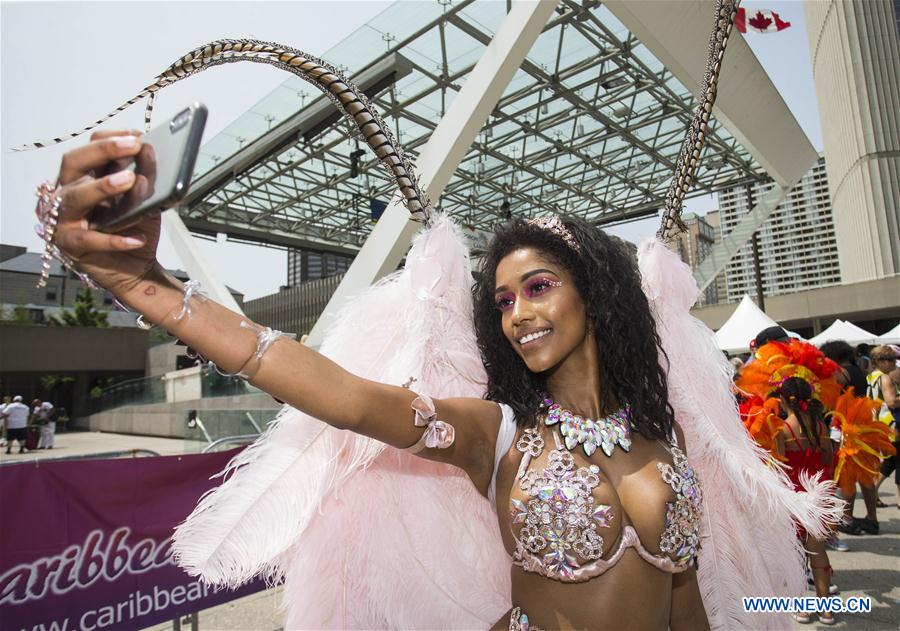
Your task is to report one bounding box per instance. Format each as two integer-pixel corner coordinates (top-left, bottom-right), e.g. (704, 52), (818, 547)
(474, 217), (675, 440)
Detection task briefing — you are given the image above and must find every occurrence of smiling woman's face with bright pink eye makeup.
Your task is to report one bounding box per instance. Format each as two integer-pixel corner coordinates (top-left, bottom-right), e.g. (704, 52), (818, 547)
(494, 248), (594, 373)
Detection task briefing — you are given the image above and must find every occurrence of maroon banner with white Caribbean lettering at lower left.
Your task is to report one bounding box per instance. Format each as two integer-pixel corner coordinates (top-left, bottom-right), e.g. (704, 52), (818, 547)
(0, 450), (264, 631)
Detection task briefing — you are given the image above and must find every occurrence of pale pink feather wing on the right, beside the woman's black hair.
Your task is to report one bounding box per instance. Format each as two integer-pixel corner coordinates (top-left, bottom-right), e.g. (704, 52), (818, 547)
(638, 238), (841, 629)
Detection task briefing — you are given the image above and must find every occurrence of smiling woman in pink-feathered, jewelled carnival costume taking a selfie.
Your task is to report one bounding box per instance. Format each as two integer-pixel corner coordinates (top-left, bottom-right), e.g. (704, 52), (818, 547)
(21, 0), (840, 629)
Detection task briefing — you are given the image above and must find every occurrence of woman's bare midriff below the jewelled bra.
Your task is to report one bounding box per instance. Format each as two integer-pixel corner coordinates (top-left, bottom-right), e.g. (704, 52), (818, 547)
(492, 549), (672, 630)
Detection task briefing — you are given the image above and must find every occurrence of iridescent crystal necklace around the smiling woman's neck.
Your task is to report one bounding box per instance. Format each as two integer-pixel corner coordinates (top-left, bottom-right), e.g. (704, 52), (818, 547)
(541, 392), (631, 456)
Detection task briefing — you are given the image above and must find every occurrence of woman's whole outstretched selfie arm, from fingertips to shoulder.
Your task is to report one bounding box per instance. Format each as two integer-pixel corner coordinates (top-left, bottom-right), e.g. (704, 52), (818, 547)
(47, 132), (501, 493)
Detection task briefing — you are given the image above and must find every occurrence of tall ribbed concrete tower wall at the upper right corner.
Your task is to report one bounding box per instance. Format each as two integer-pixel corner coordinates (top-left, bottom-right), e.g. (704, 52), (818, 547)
(804, 0), (900, 282)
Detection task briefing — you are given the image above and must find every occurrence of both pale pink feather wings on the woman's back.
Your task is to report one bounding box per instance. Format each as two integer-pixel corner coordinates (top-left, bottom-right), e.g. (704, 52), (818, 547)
(175, 225), (840, 629)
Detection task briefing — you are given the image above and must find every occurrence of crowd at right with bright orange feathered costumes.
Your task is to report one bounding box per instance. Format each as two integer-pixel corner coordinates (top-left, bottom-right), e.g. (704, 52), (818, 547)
(731, 326), (900, 624)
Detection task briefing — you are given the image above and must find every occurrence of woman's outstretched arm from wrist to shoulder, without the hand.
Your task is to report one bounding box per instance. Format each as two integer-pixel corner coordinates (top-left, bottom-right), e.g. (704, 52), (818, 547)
(132, 266), (501, 489)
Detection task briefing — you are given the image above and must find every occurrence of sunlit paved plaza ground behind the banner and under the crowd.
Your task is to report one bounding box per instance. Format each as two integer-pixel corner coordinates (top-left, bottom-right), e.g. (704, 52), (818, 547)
(0, 432), (900, 631)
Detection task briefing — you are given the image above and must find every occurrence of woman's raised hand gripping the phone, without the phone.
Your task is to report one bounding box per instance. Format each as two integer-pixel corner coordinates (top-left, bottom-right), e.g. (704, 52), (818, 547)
(54, 130), (167, 298)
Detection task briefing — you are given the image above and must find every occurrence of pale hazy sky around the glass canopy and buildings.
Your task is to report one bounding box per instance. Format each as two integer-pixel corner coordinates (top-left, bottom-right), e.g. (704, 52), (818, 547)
(0, 0), (822, 298)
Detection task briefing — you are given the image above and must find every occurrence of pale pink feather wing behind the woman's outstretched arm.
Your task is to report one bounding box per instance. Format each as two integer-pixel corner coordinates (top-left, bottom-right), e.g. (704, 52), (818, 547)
(174, 217), (510, 628)
